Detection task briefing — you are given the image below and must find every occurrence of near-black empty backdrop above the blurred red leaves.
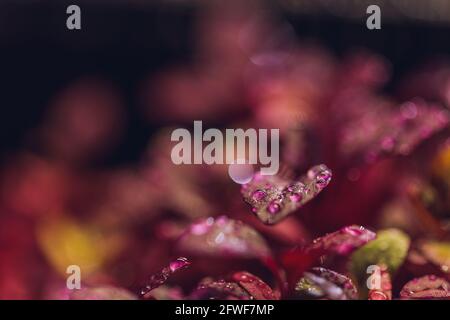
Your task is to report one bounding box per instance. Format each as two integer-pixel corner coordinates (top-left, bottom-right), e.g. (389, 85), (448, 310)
(0, 1), (450, 165)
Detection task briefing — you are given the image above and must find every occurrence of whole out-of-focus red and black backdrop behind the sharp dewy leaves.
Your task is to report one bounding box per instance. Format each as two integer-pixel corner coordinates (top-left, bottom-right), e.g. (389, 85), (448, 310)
(0, 0), (450, 299)
